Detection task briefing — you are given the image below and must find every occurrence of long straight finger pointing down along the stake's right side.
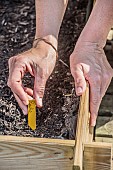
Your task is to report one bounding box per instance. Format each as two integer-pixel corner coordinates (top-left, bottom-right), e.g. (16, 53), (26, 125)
(90, 83), (102, 126)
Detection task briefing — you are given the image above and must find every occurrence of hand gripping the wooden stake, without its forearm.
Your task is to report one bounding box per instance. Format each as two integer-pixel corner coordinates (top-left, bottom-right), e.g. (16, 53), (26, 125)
(70, 42), (113, 126)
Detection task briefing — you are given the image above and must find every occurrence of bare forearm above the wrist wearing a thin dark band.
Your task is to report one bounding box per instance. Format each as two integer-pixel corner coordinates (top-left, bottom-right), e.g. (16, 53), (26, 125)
(35, 0), (68, 46)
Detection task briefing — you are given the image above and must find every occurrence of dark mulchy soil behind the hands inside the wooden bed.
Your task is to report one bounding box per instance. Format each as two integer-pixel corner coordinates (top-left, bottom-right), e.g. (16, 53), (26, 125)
(0, 0), (87, 139)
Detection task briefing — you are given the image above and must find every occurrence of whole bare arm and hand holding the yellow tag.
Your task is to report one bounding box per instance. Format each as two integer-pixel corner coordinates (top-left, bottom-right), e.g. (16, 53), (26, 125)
(7, 0), (68, 115)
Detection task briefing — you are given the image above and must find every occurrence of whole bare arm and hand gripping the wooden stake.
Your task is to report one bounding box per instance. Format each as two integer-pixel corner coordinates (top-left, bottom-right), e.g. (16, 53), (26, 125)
(70, 0), (113, 126)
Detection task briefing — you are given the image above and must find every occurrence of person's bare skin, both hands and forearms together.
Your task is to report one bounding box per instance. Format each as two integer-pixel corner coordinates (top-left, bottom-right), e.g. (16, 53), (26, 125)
(8, 0), (113, 126)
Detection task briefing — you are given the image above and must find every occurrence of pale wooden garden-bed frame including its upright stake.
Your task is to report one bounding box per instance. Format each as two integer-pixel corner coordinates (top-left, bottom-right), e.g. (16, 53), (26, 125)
(0, 85), (112, 170)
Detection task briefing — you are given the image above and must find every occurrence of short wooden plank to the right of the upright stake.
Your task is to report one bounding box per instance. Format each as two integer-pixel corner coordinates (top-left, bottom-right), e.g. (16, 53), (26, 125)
(83, 142), (112, 170)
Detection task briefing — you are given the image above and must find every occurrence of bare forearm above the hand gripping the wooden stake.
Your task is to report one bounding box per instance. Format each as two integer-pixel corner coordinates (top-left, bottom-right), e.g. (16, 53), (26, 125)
(78, 0), (113, 47)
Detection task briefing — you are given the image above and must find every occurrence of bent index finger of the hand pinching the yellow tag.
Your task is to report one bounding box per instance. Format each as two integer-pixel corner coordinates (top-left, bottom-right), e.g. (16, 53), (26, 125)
(7, 66), (28, 105)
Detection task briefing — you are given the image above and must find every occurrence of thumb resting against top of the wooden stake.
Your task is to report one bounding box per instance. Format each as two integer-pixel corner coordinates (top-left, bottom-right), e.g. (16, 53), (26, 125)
(71, 65), (86, 96)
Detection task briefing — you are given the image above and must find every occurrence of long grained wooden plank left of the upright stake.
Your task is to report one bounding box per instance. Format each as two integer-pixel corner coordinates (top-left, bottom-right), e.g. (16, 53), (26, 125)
(0, 136), (74, 170)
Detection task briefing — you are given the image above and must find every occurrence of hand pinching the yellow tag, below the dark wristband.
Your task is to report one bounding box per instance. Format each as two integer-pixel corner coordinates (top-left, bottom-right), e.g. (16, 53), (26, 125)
(8, 37), (56, 114)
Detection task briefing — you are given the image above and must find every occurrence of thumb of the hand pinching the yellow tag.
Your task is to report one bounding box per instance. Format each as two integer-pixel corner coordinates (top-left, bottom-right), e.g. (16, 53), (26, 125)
(34, 75), (46, 107)
